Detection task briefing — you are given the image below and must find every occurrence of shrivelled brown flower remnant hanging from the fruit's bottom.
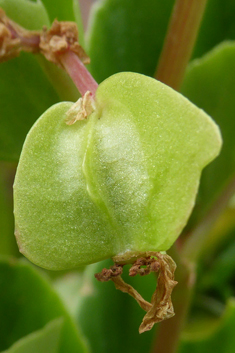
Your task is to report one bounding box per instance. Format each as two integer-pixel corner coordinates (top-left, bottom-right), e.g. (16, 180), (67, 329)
(95, 252), (177, 333)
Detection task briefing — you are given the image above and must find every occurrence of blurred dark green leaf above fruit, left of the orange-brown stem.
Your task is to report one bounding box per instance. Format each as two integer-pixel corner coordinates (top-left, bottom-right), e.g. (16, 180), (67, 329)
(87, 0), (174, 82)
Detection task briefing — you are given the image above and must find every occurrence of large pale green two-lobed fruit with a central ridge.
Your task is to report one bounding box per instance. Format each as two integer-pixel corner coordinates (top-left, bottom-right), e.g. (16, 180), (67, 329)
(14, 73), (221, 270)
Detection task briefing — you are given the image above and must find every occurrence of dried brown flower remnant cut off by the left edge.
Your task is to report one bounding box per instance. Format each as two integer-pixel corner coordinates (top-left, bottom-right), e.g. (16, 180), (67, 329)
(0, 8), (40, 62)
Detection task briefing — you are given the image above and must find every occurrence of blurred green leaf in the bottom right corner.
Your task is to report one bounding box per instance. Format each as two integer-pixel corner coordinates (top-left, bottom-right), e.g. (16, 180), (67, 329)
(177, 298), (235, 353)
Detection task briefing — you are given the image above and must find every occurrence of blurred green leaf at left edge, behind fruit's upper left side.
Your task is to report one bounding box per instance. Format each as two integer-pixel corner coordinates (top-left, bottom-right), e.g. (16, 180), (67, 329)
(0, 53), (59, 161)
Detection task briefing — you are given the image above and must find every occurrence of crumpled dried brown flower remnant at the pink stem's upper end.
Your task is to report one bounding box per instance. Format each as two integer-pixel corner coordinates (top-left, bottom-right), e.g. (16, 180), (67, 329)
(40, 20), (90, 66)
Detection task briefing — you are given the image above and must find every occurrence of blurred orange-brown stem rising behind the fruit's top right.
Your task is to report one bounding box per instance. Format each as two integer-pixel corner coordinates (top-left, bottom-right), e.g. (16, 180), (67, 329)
(155, 0), (207, 90)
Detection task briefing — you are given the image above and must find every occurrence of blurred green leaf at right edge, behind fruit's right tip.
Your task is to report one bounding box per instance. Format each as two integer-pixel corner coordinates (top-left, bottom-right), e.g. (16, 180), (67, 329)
(182, 42), (235, 219)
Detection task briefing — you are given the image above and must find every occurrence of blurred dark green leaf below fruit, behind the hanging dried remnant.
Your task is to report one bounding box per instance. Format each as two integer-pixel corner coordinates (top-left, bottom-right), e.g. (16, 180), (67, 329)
(77, 261), (156, 353)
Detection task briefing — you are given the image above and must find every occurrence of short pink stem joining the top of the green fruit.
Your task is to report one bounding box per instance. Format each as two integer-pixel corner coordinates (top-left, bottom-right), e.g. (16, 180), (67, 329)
(59, 51), (98, 96)
